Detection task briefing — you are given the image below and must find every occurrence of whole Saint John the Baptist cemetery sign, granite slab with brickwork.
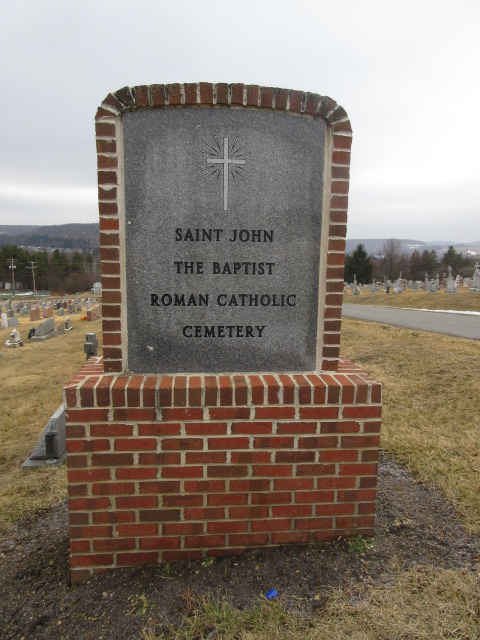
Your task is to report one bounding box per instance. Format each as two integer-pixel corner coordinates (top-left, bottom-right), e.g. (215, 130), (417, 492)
(64, 82), (381, 581)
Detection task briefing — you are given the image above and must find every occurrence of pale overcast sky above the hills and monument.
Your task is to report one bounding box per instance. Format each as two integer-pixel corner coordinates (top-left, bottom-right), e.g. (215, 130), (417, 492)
(0, 0), (480, 241)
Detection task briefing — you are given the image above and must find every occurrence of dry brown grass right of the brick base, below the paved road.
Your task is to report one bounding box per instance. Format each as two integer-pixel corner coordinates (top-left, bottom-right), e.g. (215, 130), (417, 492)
(341, 320), (480, 533)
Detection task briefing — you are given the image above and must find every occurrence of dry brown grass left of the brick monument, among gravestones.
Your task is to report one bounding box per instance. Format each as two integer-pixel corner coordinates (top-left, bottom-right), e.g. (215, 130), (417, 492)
(0, 313), (101, 532)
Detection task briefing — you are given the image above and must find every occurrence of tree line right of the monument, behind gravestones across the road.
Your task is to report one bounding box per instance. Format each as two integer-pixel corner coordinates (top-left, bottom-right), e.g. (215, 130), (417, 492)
(345, 238), (475, 284)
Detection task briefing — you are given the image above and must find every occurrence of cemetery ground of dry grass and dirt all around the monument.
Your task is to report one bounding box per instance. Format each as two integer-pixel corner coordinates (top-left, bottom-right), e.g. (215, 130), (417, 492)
(0, 292), (480, 640)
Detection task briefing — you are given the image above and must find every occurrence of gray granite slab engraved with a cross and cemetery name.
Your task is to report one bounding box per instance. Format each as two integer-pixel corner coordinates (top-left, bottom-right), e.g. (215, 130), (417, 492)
(123, 108), (325, 373)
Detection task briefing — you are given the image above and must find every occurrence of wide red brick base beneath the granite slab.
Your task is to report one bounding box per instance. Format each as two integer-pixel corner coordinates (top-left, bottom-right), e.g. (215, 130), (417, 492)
(64, 358), (381, 581)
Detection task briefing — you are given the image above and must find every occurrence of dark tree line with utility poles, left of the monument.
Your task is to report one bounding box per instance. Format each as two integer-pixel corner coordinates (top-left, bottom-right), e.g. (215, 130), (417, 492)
(0, 245), (100, 293)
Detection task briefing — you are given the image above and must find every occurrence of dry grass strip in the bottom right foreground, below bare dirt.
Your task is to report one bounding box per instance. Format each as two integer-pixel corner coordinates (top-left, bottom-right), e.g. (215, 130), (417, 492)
(142, 570), (480, 640)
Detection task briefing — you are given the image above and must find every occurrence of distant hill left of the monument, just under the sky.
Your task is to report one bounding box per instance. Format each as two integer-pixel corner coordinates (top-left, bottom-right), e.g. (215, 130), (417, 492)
(0, 222), (99, 252)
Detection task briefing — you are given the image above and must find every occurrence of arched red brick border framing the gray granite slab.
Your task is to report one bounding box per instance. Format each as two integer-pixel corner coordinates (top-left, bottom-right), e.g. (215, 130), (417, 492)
(95, 82), (352, 373)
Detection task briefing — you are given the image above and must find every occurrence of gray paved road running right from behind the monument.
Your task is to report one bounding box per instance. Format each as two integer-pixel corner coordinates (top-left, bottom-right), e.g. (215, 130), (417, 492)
(342, 304), (480, 340)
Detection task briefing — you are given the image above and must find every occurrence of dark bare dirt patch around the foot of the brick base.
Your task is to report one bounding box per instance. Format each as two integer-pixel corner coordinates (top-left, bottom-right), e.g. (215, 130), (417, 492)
(0, 456), (480, 640)
